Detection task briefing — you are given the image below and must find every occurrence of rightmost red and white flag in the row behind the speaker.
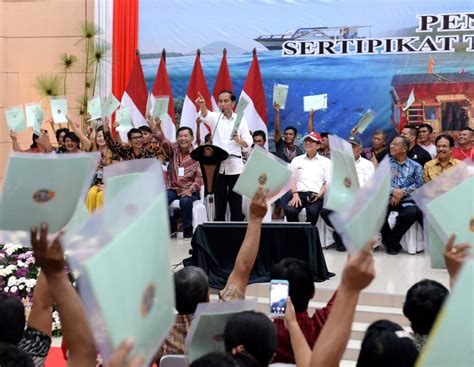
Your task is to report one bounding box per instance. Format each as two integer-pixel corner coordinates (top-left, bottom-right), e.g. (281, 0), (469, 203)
(240, 49), (268, 144)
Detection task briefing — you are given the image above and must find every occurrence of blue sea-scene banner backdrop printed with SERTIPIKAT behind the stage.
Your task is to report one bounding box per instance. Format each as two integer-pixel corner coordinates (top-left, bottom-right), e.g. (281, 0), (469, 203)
(139, 0), (474, 146)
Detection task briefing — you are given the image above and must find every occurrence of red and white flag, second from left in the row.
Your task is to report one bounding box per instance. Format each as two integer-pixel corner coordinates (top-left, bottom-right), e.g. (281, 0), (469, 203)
(151, 49), (176, 142)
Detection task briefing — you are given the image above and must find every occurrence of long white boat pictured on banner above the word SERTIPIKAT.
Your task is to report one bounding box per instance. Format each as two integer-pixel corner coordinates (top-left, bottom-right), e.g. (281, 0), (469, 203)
(254, 25), (372, 50)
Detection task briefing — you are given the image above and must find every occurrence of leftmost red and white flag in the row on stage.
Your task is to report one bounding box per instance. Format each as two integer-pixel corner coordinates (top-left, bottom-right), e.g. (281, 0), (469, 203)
(121, 51), (148, 132)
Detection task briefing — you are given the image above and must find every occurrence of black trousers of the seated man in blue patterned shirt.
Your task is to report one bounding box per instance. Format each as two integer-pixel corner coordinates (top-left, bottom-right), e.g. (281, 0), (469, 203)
(381, 204), (423, 250)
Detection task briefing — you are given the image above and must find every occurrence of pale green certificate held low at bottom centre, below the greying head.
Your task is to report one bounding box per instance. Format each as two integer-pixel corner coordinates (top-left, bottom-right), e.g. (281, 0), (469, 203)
(184, 300), (257, 363)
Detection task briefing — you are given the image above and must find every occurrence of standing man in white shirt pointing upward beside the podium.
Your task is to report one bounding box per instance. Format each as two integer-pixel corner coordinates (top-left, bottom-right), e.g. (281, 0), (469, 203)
(196, 90), (252, 221)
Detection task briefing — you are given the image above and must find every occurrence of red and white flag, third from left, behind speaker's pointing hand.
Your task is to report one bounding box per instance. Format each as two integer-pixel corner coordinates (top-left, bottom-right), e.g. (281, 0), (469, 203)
(180, 50), (212, 142)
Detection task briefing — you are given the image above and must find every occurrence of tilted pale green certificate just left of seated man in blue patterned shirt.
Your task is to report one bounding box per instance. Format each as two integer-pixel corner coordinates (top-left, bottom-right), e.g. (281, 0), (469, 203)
(330, 158), (391, 254)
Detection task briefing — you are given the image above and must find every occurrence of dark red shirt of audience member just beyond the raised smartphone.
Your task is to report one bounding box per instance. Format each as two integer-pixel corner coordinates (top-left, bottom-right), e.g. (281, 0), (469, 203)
(273, 291), (337, 363)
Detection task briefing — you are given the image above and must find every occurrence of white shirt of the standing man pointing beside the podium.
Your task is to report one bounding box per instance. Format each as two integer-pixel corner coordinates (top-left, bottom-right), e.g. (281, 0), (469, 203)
(200, 111), (253, 175)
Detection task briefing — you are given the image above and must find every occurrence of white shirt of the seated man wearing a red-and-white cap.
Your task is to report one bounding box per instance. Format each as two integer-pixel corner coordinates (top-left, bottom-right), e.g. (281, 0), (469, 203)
(290, 154), (331, 192)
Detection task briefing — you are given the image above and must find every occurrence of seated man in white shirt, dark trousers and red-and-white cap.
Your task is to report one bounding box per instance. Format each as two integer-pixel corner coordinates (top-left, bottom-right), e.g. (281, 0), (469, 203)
(284, 132), (331, 225)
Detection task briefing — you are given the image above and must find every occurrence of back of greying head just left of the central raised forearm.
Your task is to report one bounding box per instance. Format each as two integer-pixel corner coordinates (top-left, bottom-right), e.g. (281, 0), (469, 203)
(174, 266), (209, 315)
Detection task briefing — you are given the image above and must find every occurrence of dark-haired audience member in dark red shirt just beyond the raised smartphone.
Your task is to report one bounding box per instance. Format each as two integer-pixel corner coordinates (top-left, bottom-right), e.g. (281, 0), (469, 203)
(270, 258), (336, 363)
